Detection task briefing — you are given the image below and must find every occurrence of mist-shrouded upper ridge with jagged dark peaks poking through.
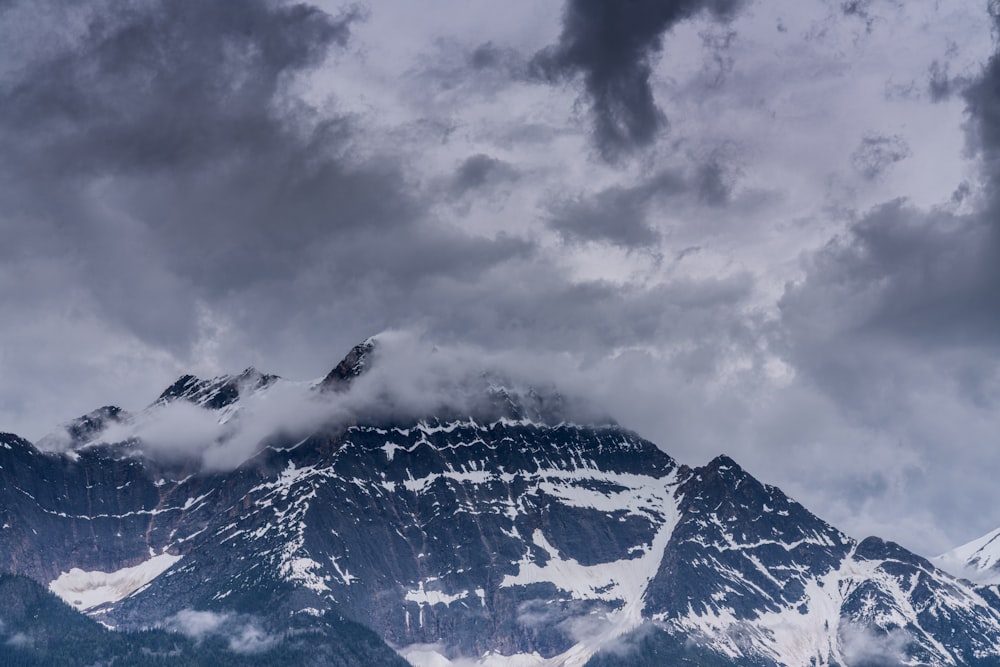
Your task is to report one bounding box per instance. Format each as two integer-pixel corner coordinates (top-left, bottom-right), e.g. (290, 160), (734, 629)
(47, 331), (611, 470)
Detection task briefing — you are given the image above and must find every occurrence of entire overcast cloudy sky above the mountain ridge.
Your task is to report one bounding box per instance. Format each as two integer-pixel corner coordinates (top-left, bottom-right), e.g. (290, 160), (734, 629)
(0, 0), (1000, 555)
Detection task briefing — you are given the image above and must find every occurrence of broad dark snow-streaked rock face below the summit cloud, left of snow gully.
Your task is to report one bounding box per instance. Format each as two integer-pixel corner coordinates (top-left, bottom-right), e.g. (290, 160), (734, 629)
(107, 423), (675, 655)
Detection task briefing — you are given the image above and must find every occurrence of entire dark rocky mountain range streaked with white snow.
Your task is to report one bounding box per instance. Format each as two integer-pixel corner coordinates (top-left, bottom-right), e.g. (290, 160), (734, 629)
(0, 340), (1000, 667)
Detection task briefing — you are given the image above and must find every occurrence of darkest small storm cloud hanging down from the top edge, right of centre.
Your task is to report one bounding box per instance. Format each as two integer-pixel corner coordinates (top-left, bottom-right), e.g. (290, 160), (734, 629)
(532, 0), (742, 159)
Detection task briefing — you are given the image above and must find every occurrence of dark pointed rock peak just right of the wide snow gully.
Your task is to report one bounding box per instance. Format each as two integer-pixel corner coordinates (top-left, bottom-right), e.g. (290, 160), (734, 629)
(646, 456), (852, 621)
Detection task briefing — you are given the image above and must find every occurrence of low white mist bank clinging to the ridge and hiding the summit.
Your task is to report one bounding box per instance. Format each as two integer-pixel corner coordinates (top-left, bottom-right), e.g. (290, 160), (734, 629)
(78, 331), (609, 470)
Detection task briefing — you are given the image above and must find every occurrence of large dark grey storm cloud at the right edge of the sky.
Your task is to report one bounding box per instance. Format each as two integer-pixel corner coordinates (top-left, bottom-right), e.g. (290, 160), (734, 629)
(780, 10), (1000, 417)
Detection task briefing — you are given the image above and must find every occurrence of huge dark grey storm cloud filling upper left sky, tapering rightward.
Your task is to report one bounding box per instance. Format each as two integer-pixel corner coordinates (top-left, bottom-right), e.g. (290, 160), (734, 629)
(0, 0), (532, 354)
